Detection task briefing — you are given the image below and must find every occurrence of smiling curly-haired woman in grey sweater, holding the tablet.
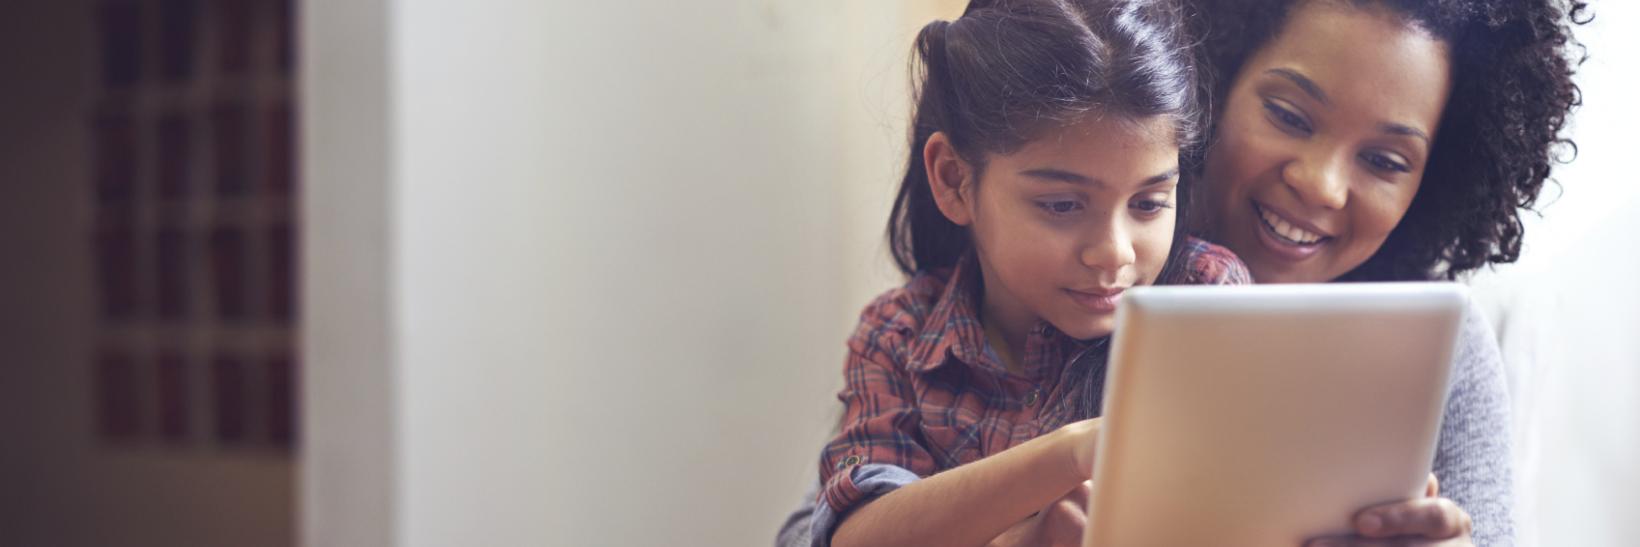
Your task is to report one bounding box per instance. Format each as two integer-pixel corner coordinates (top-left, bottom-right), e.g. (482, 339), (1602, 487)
(782, 0), (1584, 545)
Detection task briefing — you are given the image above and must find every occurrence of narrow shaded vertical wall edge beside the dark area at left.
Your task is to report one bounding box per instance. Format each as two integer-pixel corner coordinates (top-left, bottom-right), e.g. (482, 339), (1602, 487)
(297, 0), (400, 547)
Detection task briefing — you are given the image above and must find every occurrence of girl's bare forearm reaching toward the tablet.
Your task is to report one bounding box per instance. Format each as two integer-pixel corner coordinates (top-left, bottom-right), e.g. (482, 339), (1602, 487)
(831, 418), (1100, 547)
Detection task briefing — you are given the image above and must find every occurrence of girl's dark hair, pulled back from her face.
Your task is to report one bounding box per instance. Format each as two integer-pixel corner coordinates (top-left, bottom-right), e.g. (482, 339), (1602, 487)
(887, 0), (1204, 278)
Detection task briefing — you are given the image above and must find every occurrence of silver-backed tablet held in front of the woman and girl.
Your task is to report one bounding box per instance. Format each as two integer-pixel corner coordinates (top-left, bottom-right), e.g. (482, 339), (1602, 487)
(1082, 283), (1468, 547)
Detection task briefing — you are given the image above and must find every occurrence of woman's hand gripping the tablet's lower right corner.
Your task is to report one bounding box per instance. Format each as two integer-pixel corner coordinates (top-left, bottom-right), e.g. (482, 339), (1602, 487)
(1305, 475), (1474, 547)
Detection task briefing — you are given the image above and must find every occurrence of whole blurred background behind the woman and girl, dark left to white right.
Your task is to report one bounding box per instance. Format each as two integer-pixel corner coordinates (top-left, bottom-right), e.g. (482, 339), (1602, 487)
(0, 0), (1640, 545)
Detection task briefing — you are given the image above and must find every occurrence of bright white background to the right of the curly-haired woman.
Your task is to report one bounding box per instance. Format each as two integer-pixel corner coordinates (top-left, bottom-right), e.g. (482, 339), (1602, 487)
(1474, 0), (1640, 545)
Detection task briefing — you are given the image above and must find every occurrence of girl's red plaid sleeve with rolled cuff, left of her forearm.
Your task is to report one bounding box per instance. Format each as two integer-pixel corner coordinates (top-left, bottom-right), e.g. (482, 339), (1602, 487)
(818, 301), (936, 524)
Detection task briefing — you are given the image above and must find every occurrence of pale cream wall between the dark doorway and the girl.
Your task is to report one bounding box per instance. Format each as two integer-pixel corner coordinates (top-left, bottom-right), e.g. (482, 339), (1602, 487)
(303, 0), (951, 545)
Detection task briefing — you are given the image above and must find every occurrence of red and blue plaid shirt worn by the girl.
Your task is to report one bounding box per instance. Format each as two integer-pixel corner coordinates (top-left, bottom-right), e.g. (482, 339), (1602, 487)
(820, 237), (1251, 514)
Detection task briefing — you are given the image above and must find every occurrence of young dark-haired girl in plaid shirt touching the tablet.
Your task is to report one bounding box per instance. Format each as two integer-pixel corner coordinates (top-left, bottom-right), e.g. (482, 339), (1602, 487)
(812, 0), (1248, 545)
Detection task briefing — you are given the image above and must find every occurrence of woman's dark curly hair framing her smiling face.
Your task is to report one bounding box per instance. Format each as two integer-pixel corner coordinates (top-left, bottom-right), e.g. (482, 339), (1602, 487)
(1192, 0), (1591, 280)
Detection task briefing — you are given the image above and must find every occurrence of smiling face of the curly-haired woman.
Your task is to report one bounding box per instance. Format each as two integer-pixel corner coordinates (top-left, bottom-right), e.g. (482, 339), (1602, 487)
(1204, 2), (1451, 283)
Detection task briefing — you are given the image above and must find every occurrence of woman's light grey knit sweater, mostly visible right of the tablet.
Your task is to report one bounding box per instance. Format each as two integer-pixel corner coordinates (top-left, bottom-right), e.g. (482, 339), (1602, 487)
(774, 306), (1515, 547)
